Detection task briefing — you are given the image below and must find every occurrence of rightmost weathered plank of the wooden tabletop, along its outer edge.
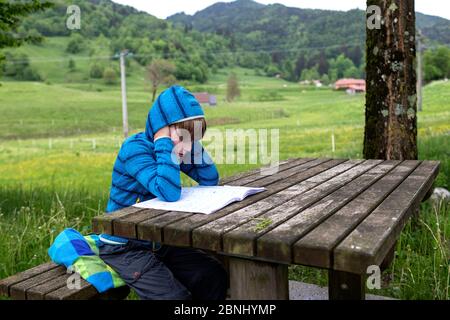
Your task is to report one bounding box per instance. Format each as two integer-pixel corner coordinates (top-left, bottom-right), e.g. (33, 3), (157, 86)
(333, 161), (439, 274)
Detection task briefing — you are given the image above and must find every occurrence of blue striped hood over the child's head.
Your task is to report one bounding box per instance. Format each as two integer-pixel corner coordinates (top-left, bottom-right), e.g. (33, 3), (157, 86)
(145, 85), (204, 141)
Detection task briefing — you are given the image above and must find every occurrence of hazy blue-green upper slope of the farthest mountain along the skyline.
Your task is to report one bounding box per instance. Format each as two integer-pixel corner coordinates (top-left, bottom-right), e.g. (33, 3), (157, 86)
(168, 0), (450, 47)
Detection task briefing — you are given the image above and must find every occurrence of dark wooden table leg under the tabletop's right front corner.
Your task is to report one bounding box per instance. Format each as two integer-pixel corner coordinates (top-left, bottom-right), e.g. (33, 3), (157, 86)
(328, 269), (366, 300)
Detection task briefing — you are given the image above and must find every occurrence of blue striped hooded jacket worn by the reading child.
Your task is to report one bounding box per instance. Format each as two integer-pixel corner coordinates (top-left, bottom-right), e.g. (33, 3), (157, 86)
(106, 86), (219, 212)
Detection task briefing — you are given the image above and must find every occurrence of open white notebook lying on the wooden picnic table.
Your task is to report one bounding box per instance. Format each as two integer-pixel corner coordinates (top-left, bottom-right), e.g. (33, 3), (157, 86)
(133, 185), (266, 214)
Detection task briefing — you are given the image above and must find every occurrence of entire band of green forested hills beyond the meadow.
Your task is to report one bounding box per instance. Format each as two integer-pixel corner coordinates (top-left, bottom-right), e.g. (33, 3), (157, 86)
(4, 0), (450, 83)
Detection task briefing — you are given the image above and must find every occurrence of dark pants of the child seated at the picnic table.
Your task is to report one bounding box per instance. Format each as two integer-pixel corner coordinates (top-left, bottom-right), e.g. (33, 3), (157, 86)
(100, 239), (228, 300)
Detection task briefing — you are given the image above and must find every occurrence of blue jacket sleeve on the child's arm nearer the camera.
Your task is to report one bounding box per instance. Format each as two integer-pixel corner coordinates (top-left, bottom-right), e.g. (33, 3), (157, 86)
(122, 137), (181, 201)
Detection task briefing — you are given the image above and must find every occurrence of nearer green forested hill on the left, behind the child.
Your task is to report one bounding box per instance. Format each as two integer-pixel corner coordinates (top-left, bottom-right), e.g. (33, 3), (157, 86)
(12, 0), (233, 82)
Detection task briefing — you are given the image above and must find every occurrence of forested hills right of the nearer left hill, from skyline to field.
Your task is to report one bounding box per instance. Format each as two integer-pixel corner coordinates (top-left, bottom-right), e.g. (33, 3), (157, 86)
(168, 0), (450, 81)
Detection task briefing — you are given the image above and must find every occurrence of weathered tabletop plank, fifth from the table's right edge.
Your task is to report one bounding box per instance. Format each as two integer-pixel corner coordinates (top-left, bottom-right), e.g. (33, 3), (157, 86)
(192, 160), (363, 251)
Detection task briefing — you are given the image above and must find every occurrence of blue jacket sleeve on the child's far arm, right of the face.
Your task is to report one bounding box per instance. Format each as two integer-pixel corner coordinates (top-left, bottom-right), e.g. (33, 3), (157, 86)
(180, 141), (219, 186)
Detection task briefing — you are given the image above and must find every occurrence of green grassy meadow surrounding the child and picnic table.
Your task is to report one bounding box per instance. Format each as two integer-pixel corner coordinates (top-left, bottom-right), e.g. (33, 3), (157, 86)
(0, 57), (450, 299)
